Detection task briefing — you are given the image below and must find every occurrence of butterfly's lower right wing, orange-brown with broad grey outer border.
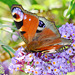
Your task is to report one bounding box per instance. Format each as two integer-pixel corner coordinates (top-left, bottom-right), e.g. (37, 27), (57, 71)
(27, 17), (70, 52)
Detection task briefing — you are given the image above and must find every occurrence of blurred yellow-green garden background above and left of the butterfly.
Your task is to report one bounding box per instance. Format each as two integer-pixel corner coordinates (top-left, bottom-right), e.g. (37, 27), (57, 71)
(0, 0), (75, 75)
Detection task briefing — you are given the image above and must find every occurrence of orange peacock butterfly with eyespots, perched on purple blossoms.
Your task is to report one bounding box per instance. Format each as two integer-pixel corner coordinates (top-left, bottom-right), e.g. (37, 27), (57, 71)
(11, 5), (70, 53)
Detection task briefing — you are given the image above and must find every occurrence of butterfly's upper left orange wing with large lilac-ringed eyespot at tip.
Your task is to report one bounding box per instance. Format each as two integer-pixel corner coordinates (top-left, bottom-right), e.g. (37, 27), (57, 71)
(11, 5), (39, 43)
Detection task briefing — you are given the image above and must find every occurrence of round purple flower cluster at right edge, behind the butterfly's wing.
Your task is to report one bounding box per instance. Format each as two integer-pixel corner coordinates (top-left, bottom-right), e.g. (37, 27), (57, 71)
(59, 23), (75, 49)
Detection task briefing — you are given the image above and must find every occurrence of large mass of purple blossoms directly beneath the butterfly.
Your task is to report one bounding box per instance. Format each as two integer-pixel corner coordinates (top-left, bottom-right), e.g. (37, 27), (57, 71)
(9, 47), (74, 75)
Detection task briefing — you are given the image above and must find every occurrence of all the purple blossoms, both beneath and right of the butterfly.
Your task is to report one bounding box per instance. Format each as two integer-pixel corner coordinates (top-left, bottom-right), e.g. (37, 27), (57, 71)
(9, 23), (75, 75)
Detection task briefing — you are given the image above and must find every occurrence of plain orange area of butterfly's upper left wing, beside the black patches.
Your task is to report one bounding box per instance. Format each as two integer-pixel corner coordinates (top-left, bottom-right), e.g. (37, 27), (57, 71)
(20, 13), (39, 42)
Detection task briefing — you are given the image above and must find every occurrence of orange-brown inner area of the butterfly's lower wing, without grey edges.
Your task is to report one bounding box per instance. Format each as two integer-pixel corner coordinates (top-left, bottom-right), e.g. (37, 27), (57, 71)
(27, 28), (62, 51)
